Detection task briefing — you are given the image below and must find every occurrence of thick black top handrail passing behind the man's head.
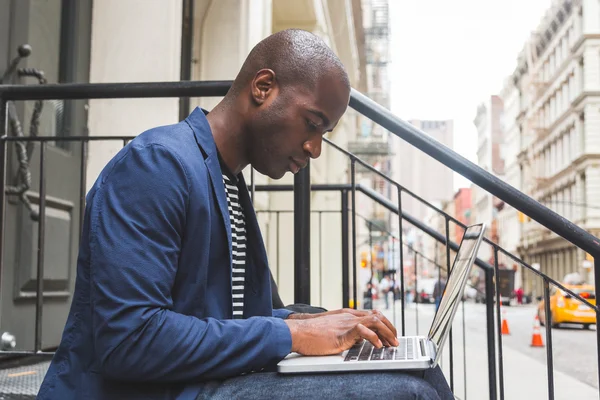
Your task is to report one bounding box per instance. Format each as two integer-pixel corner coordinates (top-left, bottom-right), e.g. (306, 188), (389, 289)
(0, 81), (600, 253)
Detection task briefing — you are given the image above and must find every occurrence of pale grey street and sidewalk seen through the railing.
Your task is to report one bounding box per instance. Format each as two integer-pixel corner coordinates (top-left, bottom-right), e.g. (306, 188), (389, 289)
(375, 301), (598, 400)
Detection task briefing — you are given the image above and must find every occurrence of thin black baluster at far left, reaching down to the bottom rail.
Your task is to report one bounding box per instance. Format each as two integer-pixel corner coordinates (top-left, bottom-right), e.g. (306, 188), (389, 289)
(35, 142), (47, 352)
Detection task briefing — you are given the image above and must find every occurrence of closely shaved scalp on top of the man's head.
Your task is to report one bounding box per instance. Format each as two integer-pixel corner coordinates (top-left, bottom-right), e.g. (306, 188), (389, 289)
(232, 29), (350, 95)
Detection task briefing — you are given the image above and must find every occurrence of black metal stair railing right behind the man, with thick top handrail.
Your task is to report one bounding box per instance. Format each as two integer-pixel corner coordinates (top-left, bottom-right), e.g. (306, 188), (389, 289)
(0, 81), (600, 399)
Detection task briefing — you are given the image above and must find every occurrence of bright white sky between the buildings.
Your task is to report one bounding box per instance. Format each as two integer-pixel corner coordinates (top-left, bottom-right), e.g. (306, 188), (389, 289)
(389, 0), (551, 189)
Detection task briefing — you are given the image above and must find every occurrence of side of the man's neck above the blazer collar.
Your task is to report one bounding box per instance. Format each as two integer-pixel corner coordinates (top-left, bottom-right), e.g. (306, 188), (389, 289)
(206, 101), (249, 176)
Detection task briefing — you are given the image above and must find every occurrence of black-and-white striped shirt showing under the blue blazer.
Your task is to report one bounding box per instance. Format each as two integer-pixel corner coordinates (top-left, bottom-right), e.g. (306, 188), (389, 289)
(223, 174), (246, 319)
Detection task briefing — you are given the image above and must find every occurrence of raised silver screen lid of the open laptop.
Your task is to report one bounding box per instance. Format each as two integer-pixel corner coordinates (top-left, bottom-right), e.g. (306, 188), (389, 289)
(428, 224), (485, 366)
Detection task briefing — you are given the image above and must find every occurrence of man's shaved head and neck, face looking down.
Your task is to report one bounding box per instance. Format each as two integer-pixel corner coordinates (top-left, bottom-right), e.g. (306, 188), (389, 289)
(208, 29), (350, 179)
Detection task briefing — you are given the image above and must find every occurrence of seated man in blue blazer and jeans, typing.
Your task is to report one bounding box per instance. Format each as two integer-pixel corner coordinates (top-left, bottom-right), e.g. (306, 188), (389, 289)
(39, 30), (451, 400)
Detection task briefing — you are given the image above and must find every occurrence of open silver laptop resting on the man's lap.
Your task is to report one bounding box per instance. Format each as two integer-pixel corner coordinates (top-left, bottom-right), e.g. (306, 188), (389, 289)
(277, 224), (485, 374)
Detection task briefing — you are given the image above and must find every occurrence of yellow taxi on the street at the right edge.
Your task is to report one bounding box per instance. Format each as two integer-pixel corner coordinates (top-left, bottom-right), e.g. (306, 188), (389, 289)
(538, 285), (596, 329)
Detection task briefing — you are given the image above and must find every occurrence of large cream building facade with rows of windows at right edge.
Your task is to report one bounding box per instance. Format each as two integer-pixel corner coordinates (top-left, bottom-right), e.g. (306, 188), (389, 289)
(504, 0), (600, 295)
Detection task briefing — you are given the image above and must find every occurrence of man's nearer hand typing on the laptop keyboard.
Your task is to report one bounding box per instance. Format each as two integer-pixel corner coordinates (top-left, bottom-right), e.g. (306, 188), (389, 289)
(285, 310), (398, 356)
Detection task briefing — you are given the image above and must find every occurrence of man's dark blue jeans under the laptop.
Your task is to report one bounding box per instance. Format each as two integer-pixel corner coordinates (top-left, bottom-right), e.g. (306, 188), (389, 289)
(190, 367), (454, 400)
